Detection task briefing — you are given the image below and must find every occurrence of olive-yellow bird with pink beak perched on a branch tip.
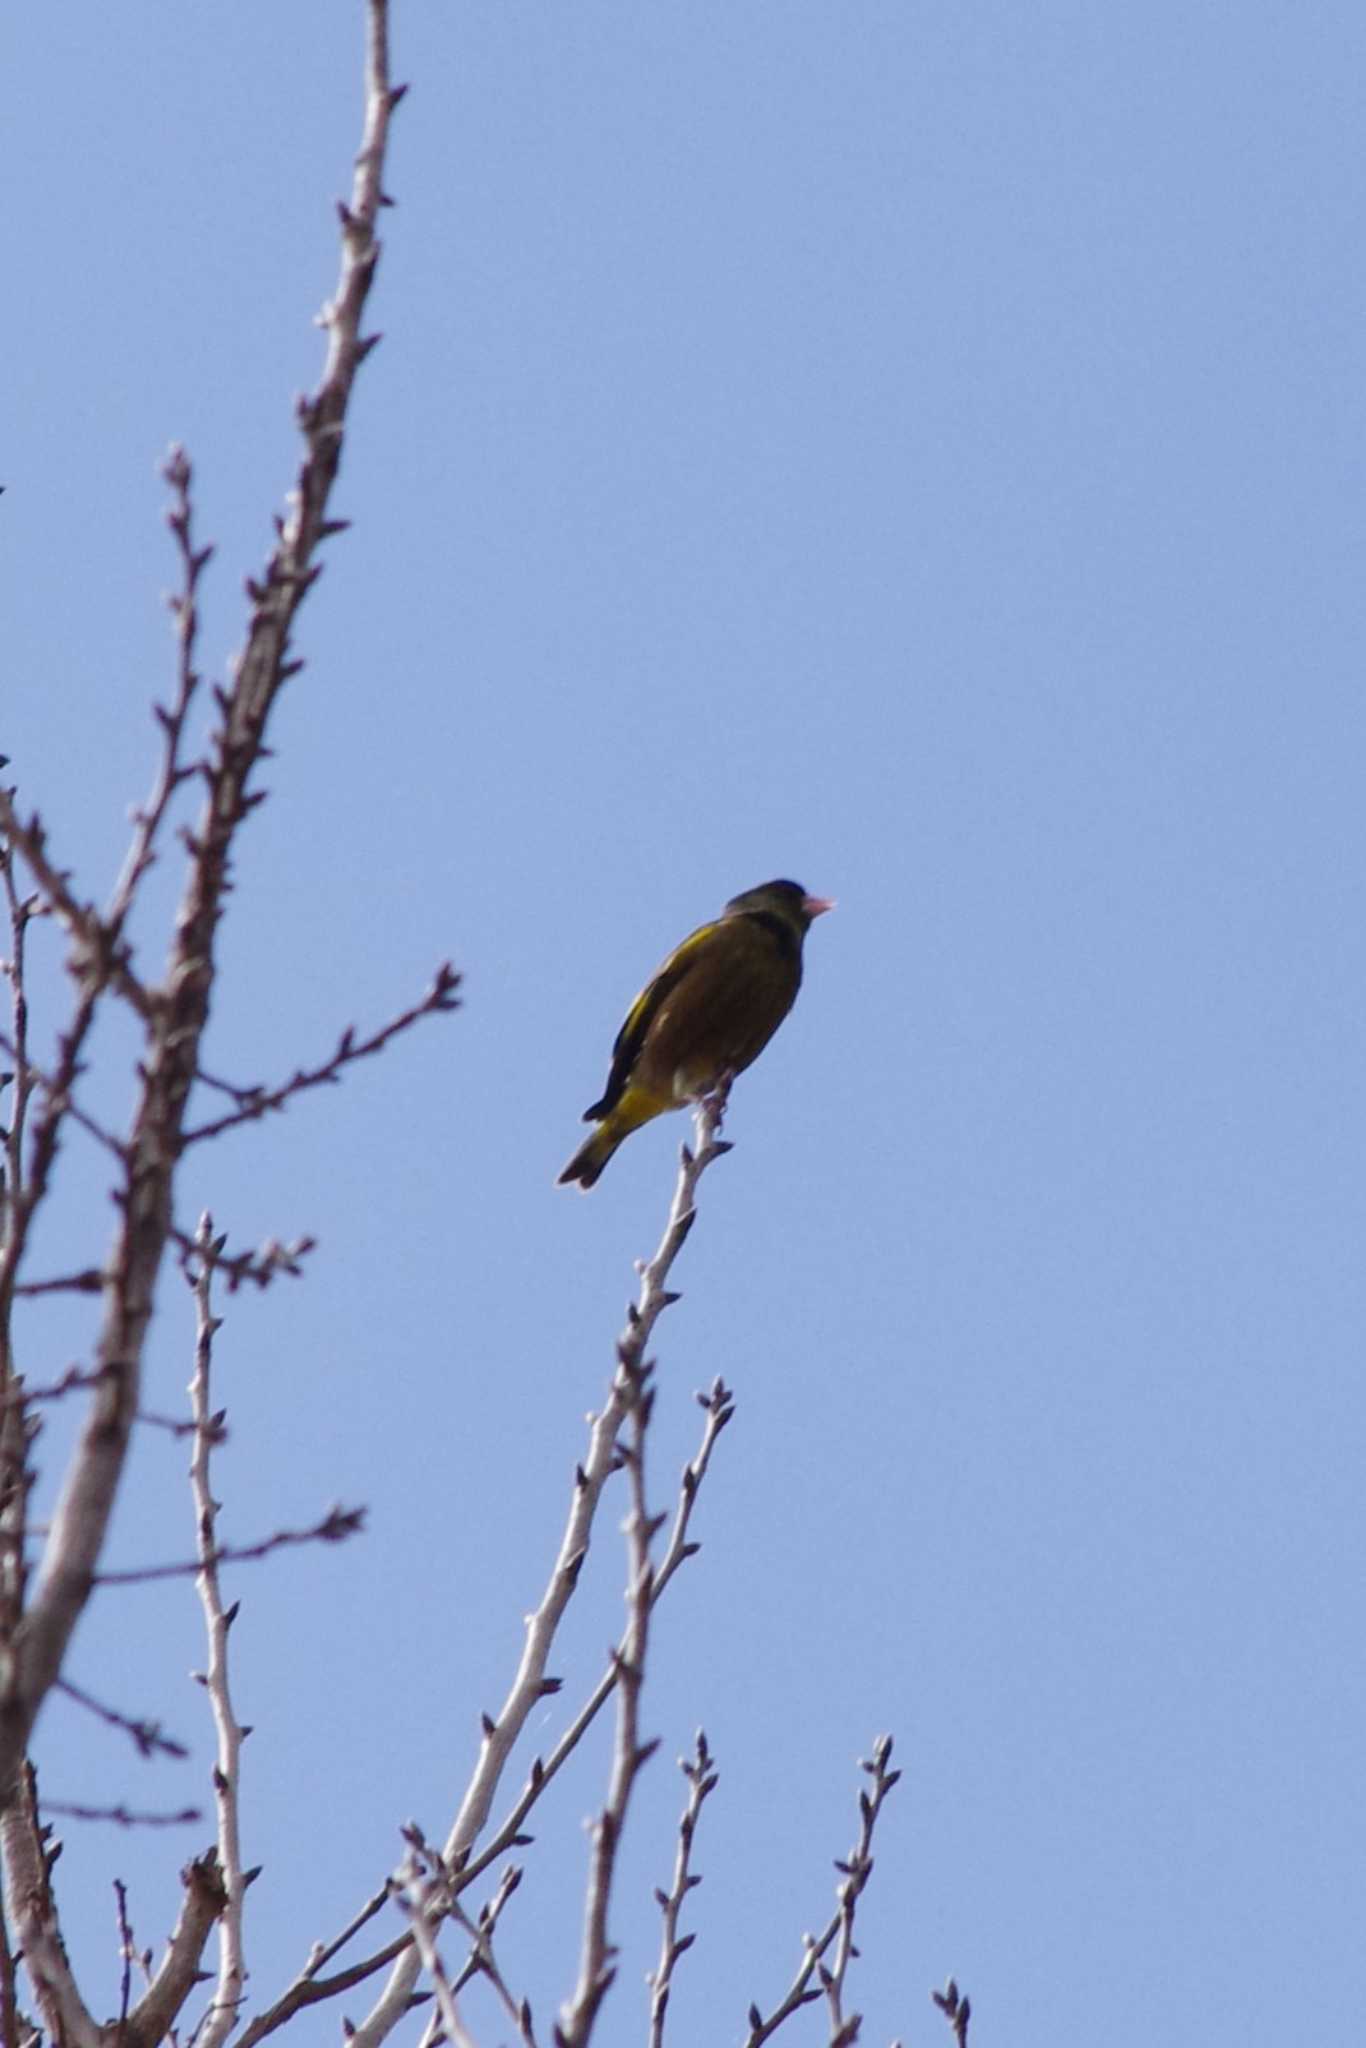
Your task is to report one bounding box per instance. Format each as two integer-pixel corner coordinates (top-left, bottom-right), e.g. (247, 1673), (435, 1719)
(559, 883), (836, 1188)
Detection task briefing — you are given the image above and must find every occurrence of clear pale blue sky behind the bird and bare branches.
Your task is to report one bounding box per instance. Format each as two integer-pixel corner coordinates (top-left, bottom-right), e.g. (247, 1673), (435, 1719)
(0, 0), (1366, 2048)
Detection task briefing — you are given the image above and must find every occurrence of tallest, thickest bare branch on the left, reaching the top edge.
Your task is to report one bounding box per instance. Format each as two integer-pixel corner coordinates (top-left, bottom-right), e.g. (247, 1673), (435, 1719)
(0, 0), (411, 1802)
